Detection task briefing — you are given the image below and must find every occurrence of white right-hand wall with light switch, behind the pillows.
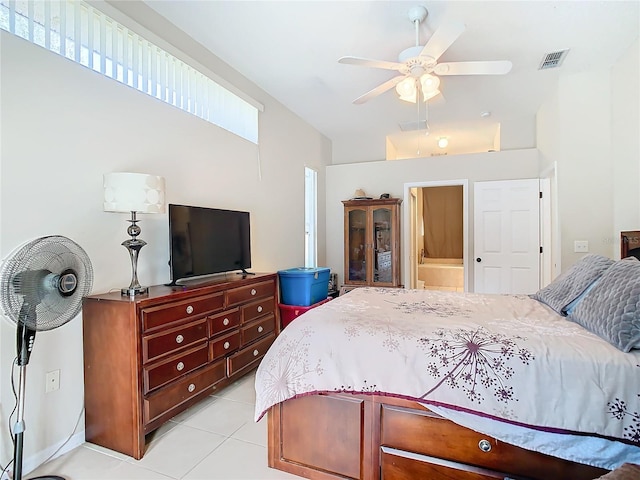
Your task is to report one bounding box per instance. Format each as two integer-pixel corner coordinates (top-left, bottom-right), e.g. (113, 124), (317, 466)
(537, 40), (640, 270)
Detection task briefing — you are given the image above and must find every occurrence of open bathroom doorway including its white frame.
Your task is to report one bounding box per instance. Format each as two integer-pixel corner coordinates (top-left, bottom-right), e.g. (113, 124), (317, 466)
(404, 180), (469, 292)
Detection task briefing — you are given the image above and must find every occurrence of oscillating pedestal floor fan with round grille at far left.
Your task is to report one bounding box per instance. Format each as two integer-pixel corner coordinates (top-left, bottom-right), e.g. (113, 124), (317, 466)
(0, 236), (93, 480)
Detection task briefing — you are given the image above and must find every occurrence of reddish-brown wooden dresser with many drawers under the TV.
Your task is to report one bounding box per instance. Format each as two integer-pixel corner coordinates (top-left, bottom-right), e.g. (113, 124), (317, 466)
(82, 273), (280, 459)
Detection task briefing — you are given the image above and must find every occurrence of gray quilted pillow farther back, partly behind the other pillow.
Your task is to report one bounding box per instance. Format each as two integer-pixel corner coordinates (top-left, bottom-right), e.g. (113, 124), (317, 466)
(532, 253), (614, 315)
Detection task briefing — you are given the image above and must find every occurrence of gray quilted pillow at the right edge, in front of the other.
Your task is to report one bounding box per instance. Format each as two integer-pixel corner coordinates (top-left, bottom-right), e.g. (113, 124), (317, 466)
(568, 257), (640, 352)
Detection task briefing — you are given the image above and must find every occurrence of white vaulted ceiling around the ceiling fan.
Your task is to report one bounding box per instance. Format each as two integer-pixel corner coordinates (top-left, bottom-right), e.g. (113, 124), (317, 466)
(146, 0), (640, 163)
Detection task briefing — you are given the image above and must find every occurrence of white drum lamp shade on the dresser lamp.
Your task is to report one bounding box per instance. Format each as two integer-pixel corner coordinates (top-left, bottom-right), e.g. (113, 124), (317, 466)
(104, 172), (165, 213)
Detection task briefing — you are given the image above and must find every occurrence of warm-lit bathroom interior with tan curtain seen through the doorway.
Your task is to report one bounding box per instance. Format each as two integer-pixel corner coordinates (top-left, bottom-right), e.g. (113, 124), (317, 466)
(415, 185), (464, 292)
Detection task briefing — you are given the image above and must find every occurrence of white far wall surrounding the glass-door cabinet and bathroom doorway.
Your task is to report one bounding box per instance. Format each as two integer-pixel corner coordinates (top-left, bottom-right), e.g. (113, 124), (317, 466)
(326, 149), (539, 291)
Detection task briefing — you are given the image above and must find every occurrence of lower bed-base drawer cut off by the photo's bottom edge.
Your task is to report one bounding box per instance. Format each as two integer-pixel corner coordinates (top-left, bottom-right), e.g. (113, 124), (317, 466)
(380, 447), (510, 480)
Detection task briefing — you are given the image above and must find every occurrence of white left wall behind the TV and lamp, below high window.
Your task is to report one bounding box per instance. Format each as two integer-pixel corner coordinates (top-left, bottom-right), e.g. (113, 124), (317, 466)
(0, 15), (331, 471)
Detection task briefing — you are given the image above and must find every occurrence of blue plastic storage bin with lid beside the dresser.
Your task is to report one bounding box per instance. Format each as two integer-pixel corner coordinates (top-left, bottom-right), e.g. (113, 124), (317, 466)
(278, 267), (330, 307)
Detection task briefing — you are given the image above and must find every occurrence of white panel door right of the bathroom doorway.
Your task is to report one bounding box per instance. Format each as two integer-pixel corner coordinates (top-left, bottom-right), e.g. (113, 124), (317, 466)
(473, 178), (540, 293)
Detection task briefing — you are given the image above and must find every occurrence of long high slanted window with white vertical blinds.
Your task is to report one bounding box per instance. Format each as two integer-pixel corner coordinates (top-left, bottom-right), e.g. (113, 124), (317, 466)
(0, 0), (262, 144)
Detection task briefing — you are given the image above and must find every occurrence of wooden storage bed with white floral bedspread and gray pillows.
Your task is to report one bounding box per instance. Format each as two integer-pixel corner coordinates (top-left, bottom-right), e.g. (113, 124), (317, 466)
(255, 255), (640, 480)
